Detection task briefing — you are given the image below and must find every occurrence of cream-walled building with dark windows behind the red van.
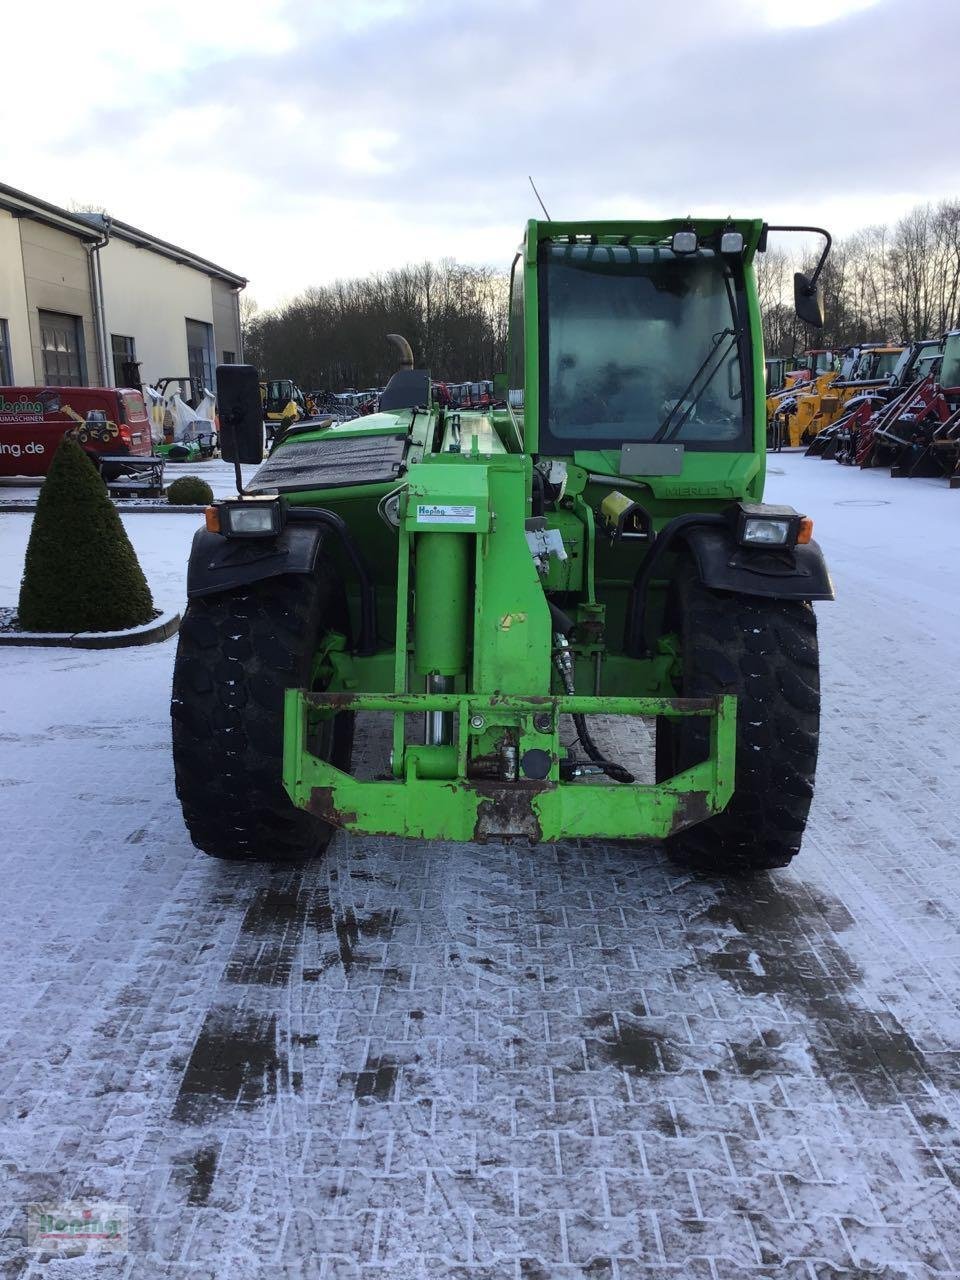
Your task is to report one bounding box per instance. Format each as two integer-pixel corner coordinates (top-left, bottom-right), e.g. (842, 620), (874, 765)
(0, 183), (247, 388)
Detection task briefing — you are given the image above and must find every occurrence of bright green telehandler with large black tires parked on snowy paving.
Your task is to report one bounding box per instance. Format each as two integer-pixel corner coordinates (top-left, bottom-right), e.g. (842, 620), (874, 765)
(172, 219), (833, 873)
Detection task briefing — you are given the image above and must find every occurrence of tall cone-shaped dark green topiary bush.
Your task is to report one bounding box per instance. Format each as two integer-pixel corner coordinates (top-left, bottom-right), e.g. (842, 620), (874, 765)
(17, 439), (154, 632)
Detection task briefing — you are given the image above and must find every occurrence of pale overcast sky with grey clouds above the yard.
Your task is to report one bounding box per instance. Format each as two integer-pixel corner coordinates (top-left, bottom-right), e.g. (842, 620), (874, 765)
(0, 0), (960, 305)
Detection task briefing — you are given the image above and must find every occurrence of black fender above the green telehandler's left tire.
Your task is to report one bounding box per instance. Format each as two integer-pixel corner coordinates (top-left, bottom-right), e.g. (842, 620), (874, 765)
(187, 522), (329, 599)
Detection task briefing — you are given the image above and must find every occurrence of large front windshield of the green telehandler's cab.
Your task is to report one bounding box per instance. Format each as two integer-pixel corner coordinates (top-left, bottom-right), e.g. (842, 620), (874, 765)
(540, 244), (750, 453)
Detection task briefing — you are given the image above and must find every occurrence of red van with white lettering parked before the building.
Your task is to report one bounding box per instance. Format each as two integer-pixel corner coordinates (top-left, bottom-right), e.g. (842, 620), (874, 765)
(0, 387), (154, 479)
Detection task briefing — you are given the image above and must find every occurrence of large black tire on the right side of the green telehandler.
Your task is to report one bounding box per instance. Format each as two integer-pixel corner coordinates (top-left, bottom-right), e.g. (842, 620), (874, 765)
(657, 563), (820, 874)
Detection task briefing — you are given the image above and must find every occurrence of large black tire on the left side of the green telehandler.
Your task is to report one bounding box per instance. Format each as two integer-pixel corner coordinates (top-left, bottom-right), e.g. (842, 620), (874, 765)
(170, 564), (353, 861)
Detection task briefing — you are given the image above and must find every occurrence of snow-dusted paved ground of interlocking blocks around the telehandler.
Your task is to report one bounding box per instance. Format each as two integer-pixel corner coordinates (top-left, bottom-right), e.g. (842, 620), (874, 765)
(0, 454), (960, 1280)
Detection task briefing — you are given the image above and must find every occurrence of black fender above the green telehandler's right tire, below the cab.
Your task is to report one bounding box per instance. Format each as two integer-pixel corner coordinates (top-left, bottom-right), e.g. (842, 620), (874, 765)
(680, 525), (836, 600)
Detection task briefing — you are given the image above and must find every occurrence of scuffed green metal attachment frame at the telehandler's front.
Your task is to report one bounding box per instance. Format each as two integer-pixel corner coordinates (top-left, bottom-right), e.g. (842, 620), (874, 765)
(283, 689), (737, 841)
